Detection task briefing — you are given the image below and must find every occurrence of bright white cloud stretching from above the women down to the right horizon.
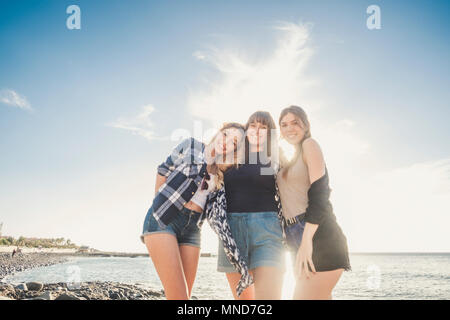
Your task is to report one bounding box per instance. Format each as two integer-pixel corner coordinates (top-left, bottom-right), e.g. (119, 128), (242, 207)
(188, 19), (450, 251)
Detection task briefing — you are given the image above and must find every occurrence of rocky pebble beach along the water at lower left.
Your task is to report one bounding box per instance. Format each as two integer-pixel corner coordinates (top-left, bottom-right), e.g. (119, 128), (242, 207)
(0, 252), (164, 300)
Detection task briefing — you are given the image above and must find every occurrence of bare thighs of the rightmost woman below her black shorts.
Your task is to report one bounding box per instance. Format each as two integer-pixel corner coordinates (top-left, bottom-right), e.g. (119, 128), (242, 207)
(294, 269), (344, 300)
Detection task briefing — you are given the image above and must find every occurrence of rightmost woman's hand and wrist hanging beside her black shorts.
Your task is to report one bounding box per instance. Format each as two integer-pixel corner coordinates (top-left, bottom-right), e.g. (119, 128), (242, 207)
(294, 223), (317, 279)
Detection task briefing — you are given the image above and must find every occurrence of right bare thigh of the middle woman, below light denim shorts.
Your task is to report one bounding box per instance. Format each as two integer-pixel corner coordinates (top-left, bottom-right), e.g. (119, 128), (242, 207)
(254, 267), (283, 300)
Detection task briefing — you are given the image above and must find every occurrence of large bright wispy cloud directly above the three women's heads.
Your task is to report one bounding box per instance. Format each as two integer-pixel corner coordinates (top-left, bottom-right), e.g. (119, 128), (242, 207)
(188, 22), (314, 125)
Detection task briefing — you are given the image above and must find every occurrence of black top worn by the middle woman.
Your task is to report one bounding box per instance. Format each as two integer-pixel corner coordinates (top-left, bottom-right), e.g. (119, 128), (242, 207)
(224, 152), (277, 212)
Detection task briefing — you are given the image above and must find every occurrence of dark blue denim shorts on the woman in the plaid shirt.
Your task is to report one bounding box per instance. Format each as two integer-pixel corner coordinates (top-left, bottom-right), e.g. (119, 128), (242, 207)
(141, 207), (201, 248)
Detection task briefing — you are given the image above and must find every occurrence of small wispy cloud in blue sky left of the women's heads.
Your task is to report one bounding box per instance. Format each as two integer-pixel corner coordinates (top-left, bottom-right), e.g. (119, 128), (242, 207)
(107, 105), (165, 140)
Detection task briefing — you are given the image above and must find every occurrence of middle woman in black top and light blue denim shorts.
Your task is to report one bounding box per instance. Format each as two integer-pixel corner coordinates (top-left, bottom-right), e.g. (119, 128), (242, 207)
(217, 111), (285, 300)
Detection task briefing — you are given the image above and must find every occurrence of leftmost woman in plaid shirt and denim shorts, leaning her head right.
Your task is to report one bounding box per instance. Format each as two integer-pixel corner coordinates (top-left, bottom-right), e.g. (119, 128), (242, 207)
(141, 123), (244, 299)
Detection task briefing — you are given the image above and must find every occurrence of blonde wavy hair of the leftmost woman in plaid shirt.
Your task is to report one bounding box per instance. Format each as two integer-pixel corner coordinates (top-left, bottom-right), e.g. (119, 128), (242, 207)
(208, 122), (244, 190)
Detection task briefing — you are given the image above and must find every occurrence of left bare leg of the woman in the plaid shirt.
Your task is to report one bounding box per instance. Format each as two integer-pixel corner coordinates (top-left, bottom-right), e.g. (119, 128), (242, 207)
(144, 233), (189, 300)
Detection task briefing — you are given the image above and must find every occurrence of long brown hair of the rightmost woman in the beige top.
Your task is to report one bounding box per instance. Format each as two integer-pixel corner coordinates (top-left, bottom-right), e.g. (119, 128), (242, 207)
(278, 106), (311, 178)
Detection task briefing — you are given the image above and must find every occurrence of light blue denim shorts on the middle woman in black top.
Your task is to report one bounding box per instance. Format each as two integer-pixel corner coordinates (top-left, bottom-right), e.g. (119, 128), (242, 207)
(217, 211), (285, 273)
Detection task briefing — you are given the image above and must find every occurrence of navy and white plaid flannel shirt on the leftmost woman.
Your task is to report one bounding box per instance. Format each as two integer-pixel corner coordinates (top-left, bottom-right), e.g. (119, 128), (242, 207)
(152, 138), (206, 228)
